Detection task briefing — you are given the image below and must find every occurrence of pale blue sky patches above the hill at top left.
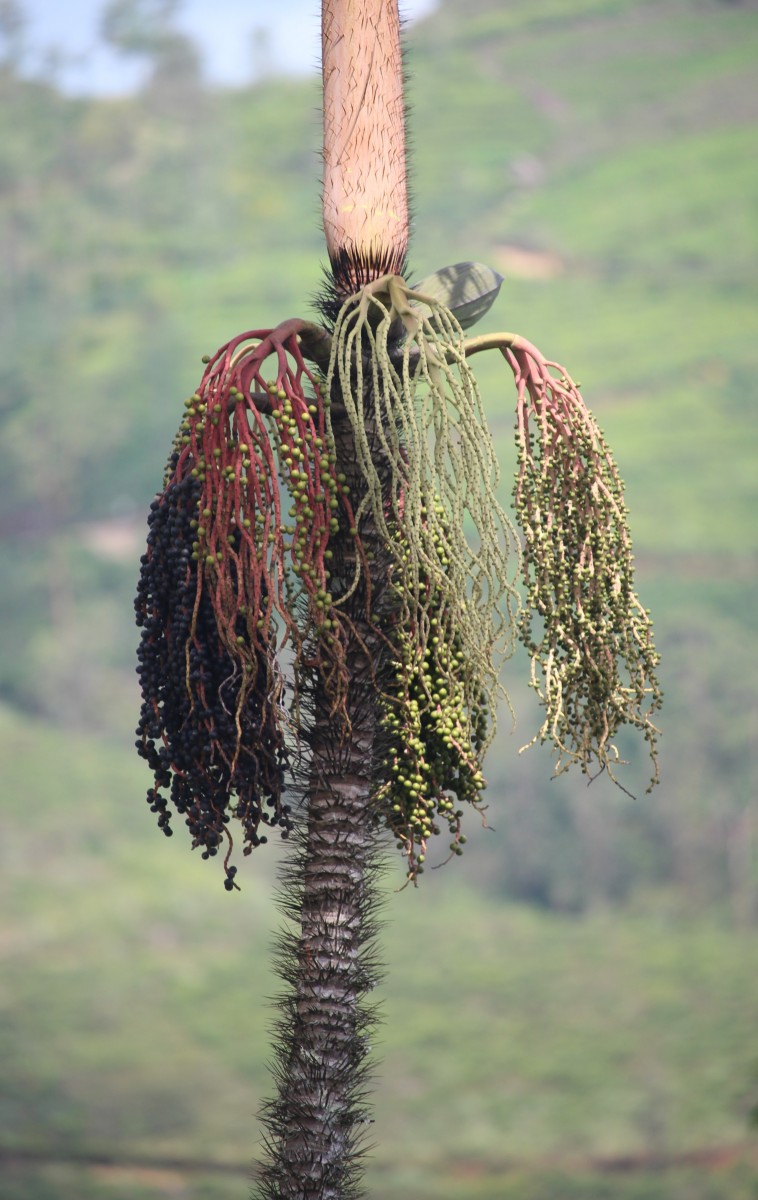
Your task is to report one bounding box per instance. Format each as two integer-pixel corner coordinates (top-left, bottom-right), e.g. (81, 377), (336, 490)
(19, 0), (435, 95)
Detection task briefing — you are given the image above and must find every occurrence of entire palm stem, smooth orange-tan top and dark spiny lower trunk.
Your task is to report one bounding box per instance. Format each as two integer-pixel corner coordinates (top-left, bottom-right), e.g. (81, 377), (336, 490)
(254, 7), (408, 1200)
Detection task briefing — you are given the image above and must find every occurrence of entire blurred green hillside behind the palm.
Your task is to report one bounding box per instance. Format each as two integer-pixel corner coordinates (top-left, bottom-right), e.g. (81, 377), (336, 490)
(0, 0), (758, 1200)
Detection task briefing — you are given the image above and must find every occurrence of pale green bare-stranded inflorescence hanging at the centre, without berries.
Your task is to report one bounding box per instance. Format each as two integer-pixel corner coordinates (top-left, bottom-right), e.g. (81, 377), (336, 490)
(327, 276), (519, 740)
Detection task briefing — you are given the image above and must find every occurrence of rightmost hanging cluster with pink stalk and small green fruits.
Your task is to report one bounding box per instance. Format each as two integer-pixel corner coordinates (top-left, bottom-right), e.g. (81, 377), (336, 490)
(503, 337), (662, 790)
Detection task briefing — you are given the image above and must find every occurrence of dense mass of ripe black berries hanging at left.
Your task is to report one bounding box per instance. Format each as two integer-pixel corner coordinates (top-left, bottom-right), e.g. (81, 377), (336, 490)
(134, 458), (291, 890)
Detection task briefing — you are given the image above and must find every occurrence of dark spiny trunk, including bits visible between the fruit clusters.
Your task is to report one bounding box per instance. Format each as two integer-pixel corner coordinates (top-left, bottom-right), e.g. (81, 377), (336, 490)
(259, 388), (386, 1200)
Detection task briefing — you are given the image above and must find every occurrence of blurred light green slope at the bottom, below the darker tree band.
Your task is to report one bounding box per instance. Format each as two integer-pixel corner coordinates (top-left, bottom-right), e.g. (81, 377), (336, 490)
(0, 710), (758, 1200)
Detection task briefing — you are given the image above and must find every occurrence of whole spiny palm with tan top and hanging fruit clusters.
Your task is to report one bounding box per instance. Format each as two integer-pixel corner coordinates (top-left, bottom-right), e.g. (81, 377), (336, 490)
(137, 0), (660, 1200)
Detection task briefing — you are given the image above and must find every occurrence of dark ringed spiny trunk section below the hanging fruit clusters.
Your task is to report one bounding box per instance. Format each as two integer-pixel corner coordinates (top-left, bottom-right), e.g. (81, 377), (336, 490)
(254, 713), (375, 1200)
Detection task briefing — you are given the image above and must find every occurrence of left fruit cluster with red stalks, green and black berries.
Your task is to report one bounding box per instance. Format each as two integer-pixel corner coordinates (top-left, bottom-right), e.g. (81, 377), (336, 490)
(136, 322), (353, 887)
